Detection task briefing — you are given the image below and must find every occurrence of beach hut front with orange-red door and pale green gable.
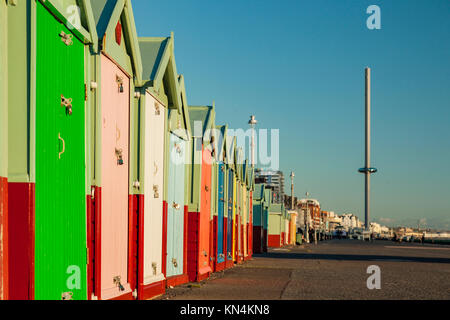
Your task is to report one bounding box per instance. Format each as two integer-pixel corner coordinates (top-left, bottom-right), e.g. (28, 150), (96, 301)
(188, 106), (215, 281)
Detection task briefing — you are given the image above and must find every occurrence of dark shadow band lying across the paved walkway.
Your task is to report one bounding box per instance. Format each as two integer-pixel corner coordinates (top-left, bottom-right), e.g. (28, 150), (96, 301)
(254, 252), (450, 263)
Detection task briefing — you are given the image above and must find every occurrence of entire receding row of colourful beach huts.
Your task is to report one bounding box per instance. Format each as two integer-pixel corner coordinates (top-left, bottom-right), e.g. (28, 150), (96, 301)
(0, 0), (295, 300)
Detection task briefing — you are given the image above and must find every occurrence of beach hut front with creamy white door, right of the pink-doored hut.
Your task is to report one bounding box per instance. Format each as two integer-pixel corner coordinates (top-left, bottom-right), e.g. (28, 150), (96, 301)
(132, 34), (184, 299)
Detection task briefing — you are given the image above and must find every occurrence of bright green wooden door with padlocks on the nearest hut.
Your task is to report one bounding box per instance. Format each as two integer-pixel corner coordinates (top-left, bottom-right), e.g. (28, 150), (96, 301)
(35, 2), (87, 300)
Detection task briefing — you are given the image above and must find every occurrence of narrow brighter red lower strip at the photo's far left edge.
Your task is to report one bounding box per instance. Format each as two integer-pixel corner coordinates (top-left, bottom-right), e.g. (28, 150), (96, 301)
(0, 177), (9, 300)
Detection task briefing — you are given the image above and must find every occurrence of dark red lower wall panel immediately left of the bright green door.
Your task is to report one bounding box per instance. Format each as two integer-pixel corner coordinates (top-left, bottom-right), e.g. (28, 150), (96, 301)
(8, 182), (35, 300)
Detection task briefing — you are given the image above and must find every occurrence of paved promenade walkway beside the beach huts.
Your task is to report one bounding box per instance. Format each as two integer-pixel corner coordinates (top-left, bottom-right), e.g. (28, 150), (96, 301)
(159, 240), (450, 300)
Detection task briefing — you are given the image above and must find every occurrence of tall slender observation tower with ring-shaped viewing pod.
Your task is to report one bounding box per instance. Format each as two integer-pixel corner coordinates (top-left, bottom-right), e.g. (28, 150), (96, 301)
(358, 68), (378, 230)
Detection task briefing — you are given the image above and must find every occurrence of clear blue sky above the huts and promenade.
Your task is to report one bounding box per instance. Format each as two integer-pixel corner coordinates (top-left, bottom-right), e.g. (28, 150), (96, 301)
(132, 0), (450, 229)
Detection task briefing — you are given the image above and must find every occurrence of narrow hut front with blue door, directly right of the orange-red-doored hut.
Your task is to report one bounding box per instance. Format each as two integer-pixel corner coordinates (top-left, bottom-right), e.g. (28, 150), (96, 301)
(213, 125), (228, 272)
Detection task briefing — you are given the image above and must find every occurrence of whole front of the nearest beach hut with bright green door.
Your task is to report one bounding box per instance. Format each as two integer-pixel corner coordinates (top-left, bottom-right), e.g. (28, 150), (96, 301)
(5, 0), (97, 300)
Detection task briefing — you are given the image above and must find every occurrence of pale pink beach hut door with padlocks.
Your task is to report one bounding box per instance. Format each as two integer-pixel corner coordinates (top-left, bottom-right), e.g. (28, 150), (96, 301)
(100, 55), (131, 300)
